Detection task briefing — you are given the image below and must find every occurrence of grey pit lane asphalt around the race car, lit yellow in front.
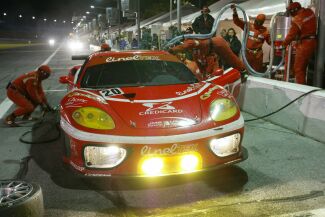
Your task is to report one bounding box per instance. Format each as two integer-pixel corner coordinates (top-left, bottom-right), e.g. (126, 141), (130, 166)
(0, 43), (325, 217)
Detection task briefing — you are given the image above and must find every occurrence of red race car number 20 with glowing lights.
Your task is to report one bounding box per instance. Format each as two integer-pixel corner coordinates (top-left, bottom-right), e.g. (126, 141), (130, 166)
(60, 51), (247, 177)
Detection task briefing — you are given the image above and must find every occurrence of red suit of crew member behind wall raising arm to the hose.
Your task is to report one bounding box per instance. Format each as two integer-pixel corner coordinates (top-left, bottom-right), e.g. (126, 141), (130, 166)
(233, 14), (270, 72)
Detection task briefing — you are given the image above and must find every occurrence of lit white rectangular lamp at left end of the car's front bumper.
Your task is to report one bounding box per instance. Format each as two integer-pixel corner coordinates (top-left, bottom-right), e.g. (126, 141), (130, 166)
(84, 146), (126, 168)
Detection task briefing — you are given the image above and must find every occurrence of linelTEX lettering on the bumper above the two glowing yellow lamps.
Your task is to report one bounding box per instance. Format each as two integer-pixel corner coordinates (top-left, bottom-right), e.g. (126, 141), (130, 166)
(141, 144), (198, 156)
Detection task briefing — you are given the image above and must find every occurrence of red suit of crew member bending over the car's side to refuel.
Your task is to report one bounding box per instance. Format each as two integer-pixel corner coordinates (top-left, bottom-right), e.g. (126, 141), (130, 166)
(171, 36), (245, 77)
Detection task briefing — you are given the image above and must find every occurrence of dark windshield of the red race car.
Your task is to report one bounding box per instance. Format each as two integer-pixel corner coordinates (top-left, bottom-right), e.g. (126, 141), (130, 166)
(81, 60), (198, 89)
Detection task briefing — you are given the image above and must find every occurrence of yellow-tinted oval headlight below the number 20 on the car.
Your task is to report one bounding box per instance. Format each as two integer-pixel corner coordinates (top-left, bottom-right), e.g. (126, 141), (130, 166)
(72, 107), (115, 130)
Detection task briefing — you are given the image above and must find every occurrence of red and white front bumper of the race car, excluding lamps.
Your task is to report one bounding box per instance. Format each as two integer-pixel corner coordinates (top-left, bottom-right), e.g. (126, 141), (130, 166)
(61, 116), (247, 177)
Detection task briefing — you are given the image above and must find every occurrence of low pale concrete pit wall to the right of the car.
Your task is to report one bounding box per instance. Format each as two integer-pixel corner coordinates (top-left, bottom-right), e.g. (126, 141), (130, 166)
(239, 76), (325, 143)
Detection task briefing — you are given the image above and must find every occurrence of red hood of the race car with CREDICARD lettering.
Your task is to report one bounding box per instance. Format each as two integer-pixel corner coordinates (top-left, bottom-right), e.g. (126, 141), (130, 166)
(92, 82), (206, 129)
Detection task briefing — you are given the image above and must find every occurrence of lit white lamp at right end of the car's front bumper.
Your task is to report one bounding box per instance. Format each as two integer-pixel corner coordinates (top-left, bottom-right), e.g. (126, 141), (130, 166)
(210, 133), (240, 157)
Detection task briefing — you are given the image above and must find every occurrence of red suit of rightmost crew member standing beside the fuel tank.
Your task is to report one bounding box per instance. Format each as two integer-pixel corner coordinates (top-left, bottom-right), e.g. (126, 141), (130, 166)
(283, 8), (317, 84)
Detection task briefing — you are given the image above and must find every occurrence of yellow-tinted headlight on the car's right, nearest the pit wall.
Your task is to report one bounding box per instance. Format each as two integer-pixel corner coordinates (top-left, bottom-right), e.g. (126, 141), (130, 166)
(210, 98), (237, 121)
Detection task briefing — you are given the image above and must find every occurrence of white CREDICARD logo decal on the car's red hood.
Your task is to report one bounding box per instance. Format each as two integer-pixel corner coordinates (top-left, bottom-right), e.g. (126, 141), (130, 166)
(139, 102), (183, 116)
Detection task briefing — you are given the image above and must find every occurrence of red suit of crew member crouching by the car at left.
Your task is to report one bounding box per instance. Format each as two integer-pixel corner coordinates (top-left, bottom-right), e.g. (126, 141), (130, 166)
(7, 71), (47, 116)
